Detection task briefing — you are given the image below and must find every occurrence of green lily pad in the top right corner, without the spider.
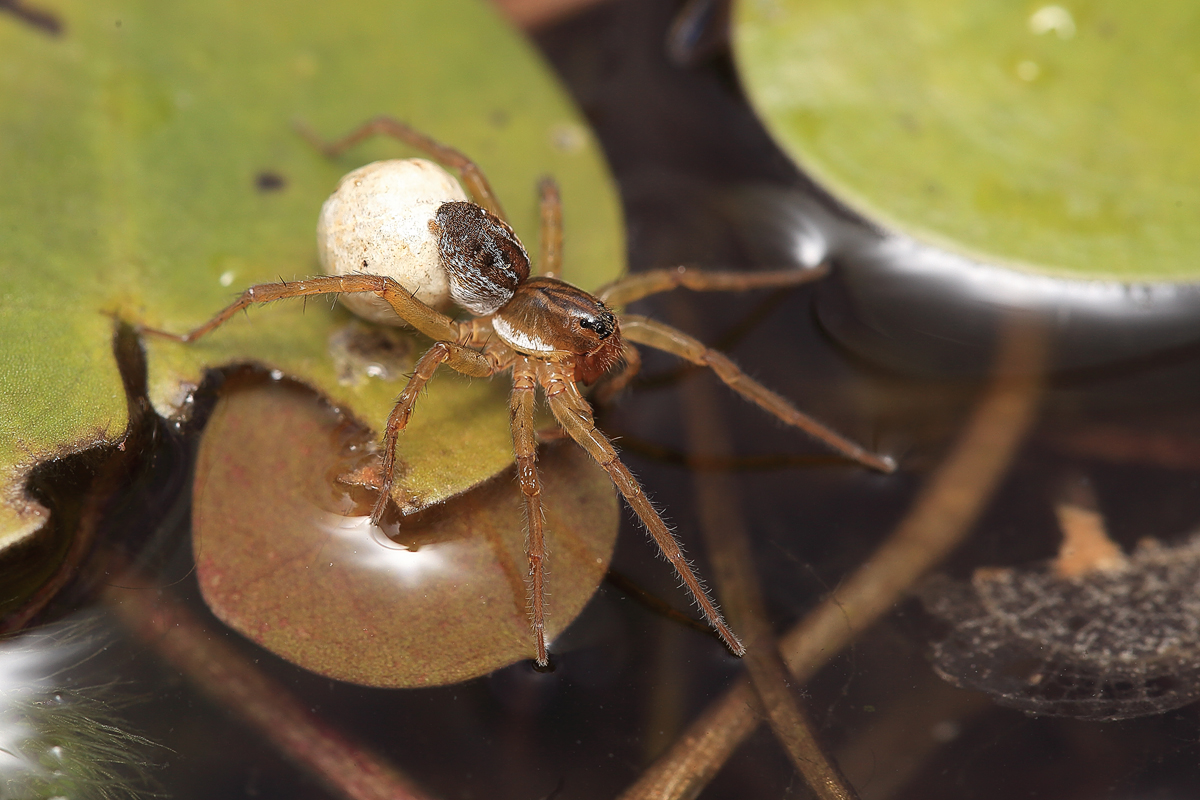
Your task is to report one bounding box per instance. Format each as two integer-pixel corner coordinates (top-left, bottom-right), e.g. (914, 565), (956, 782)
(734, 0), (1200, 281)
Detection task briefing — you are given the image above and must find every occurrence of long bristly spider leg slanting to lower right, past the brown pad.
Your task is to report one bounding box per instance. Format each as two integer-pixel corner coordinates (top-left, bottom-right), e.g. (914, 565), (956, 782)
(541, 362), (745, 656)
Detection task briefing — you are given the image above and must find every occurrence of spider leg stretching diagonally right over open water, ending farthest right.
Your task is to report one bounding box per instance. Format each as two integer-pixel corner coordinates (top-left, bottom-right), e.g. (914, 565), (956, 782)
(620, 314), (895, 473)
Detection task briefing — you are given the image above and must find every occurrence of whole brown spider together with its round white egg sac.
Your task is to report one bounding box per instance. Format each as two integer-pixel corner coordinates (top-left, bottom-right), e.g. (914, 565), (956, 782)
(145, 116), (894, 667)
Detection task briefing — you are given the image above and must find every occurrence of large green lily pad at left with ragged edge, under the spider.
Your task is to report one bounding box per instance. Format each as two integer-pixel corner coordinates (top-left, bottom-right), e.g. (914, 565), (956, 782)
(0, 0), (624, 551)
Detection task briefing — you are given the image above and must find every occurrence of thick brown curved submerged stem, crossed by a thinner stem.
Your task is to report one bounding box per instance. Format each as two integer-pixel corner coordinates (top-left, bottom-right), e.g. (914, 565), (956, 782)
(622, 320), (1045, 800)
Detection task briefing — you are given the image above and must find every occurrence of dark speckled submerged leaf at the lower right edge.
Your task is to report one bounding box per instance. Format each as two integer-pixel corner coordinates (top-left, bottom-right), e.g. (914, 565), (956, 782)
(923, 536), (1200, 720)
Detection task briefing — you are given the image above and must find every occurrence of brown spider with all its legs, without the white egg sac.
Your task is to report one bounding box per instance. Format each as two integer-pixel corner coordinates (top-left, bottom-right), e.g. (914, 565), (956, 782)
(142, 116), (894, 667)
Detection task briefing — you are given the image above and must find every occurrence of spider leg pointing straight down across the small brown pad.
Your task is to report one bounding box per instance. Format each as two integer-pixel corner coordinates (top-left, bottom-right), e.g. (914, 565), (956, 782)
(510, 357), (550, 667)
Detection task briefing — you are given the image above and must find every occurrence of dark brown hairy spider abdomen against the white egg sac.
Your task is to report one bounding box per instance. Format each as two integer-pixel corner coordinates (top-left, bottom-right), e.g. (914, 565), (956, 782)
(430, 203), (529, 317)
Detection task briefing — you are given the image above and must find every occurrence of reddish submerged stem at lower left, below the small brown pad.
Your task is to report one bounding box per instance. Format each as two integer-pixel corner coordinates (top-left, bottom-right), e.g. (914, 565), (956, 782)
(103, 581), (439, 800)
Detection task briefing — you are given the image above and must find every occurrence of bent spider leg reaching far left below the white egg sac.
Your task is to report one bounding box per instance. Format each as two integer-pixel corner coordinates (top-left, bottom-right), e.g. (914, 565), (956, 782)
(139, 275), (458, 343)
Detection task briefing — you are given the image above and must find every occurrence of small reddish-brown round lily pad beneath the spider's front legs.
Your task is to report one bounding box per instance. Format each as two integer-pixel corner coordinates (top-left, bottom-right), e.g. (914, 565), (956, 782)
(192, 381), (619, 687)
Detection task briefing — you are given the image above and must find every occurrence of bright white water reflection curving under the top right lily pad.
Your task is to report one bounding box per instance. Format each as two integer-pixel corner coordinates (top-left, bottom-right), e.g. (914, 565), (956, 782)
(730, 186), (1200, 374)
